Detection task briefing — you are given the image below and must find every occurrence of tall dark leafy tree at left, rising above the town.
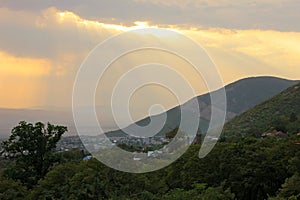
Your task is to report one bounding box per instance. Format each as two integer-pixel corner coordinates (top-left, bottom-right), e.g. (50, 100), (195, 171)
(1, 121), (67, 186)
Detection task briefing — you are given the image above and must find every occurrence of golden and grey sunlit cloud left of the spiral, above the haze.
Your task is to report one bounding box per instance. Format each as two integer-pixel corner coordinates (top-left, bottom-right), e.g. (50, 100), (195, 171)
(0, 7), (162, 107)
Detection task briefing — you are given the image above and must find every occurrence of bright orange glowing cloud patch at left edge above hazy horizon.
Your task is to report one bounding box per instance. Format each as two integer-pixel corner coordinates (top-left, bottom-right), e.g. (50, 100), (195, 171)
(0, 51), (52, 108)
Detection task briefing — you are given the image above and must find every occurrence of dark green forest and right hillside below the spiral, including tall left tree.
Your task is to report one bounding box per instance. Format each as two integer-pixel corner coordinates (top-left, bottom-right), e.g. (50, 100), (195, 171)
(0, 84), (300, 200)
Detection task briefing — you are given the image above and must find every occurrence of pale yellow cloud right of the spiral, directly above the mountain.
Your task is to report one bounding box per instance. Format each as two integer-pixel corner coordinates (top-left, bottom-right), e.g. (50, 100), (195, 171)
(184, 28), (300, 82)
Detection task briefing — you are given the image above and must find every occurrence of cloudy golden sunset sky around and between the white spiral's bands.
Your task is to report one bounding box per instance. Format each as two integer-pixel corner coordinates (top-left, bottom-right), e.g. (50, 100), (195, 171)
(0, 0), (300, 118)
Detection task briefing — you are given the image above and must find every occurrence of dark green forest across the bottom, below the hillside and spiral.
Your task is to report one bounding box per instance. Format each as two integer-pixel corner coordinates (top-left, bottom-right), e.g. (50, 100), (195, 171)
(0, 122), (300, 200)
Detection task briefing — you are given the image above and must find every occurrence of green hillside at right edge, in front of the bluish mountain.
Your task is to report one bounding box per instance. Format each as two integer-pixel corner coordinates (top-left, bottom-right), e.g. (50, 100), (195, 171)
(223, 83), (300, 137)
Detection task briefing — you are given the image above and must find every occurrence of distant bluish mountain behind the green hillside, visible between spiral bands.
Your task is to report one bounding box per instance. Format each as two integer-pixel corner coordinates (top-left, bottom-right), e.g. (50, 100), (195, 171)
(106, 77), (298, 137)
